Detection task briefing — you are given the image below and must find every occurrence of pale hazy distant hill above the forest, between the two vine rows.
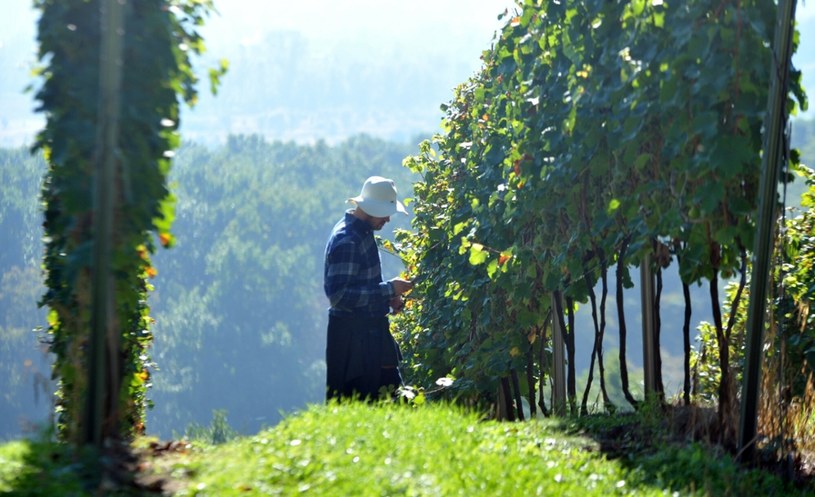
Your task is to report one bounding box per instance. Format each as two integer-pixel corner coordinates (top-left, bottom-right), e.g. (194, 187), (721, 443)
(178, 27), (488, 143)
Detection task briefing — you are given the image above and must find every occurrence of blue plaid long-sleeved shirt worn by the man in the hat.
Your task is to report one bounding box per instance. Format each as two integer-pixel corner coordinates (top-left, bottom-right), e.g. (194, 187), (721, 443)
(323, 211), (394, 317)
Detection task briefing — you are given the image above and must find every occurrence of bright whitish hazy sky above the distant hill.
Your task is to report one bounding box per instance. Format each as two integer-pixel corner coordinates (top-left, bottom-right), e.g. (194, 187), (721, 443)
(0, 0), (815, 120)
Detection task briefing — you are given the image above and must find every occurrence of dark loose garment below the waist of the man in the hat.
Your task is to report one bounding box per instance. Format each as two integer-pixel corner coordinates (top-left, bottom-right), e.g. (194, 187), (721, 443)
(325, 315), (402, 400)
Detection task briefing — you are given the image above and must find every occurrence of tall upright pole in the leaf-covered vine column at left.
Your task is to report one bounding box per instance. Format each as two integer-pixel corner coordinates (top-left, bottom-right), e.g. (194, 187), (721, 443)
(83, 0), (125, 448)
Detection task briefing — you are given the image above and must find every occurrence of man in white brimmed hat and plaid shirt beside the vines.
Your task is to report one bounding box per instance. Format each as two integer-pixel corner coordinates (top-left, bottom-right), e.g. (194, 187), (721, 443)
(323, 176), (413, 400)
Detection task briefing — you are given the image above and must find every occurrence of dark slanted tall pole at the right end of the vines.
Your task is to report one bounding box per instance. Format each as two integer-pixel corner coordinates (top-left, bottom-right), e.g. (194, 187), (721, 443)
(739, 0), (795, 461)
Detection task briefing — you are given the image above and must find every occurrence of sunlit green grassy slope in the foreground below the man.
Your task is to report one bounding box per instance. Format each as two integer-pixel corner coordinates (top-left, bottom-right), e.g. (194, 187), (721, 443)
(0, 404), (815, 497)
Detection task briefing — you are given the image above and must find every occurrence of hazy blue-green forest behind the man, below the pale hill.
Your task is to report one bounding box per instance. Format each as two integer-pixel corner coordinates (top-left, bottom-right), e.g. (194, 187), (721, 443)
(0, 120), (815, 439)
